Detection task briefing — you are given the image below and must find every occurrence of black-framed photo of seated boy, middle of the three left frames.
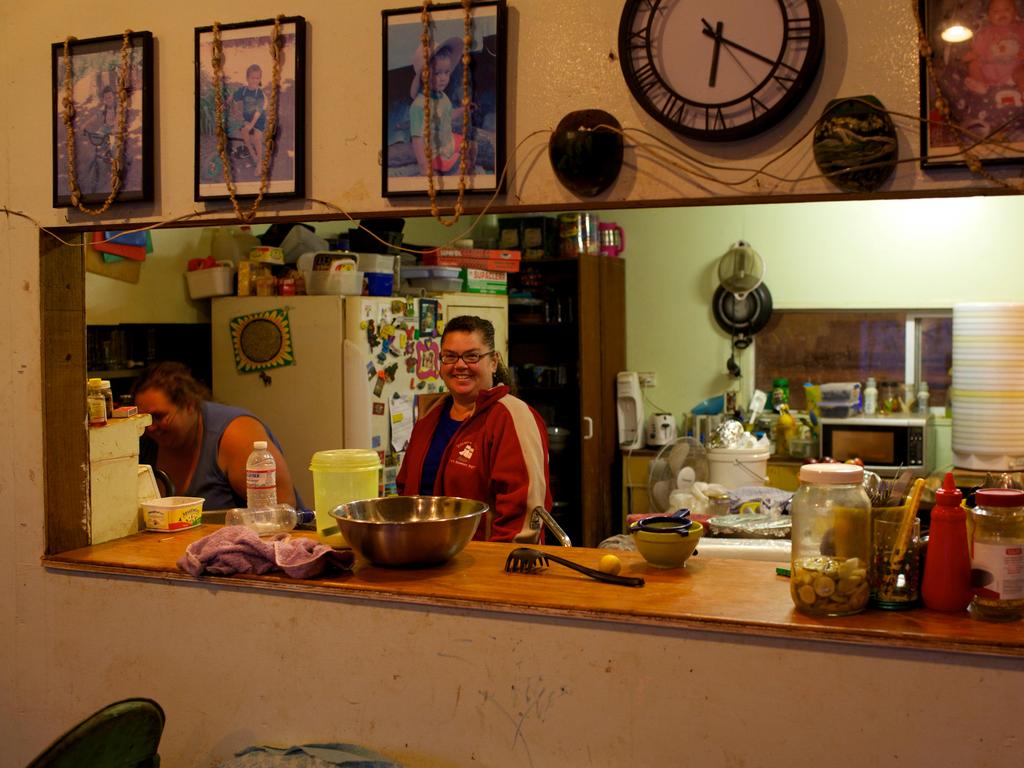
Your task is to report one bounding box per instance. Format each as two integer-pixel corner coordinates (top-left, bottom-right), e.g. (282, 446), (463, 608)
(195, 16), (306, 201)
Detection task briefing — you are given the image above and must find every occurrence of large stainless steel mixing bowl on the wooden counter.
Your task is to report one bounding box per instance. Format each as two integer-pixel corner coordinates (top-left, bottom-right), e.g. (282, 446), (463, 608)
(331, 496), (489, 566)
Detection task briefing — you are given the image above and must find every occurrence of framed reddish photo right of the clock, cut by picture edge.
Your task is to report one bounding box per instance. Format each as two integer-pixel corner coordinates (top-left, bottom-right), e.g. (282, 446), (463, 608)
(919, 0), (1024, 168)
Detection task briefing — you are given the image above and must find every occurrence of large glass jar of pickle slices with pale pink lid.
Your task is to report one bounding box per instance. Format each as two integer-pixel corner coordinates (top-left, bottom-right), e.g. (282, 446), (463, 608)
(790, 464), (871, 616)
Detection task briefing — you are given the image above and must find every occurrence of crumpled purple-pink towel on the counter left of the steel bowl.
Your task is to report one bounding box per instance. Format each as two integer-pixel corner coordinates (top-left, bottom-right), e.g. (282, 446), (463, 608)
(178, 525), (355, 579)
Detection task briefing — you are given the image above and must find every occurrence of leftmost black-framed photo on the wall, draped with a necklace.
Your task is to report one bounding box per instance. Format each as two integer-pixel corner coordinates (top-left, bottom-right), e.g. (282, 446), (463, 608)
(50, 32), (154, 208)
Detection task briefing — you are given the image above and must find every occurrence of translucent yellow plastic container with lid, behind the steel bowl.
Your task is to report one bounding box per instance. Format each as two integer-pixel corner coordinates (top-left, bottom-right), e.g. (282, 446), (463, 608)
(309, 449), (381, 548)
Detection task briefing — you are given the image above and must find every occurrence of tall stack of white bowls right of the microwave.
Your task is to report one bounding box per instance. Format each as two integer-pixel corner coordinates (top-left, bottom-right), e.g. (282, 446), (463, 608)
(950, 302), (1024, 471)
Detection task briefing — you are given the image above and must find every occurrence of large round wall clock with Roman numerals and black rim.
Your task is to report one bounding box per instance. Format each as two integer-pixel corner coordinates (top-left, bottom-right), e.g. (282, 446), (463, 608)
(618, 0), (824, 140)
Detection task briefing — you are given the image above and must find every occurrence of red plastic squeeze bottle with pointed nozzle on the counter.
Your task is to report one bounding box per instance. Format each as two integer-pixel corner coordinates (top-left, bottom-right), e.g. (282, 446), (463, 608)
(921, 472), (974, 611)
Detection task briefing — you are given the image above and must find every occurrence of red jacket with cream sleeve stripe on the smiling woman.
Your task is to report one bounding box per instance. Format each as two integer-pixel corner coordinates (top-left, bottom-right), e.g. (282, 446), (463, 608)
(397, 384), (551, 544)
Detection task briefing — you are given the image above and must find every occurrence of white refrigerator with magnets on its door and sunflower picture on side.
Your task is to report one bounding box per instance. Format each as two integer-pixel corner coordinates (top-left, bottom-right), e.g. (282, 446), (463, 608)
(211, 293), (508, 506)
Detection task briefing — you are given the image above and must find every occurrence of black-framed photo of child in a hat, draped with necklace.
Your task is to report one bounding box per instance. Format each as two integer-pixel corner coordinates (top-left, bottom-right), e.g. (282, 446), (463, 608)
(381, 0), (507, 197)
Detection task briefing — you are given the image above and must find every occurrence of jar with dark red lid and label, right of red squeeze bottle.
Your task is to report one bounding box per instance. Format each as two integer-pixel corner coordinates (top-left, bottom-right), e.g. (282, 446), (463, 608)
(968, 488), (1024, 622)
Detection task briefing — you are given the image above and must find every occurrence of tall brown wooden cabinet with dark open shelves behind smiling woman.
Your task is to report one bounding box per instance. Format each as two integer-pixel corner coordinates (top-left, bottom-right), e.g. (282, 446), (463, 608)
(508, 256), (626, 547)
